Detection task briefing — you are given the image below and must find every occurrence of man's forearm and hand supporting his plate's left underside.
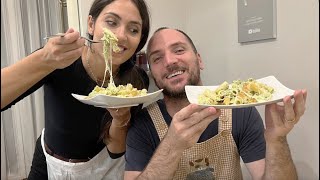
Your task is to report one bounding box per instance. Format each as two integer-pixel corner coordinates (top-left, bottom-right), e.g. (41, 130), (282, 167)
(124, 104), (220, 180)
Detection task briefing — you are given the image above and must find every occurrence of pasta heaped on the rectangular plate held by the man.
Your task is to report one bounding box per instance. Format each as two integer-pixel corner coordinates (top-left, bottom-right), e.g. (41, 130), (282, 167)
(198, 78), (274, 105)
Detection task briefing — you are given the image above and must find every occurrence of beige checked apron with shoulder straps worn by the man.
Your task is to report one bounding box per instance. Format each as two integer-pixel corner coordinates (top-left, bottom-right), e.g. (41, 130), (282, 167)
(147, 103), (242, 180)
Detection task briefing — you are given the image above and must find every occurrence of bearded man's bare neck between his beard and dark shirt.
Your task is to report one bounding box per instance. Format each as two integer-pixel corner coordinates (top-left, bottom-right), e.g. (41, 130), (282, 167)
(163, 96), (190, 117)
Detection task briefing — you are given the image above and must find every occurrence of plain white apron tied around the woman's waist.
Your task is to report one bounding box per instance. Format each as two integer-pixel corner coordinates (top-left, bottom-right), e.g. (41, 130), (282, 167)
(41, 129), (125, 180)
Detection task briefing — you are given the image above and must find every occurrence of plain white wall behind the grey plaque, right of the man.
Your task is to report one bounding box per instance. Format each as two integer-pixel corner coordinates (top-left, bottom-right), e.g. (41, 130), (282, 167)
(185, 0), (319, 179)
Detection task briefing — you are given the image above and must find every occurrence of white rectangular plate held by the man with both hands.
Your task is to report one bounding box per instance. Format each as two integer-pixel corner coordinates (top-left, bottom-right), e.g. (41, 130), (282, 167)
(185, 76), (294, 109)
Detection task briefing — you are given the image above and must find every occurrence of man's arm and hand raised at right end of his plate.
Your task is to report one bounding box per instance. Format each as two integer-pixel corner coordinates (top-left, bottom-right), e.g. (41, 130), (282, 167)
(246, 90), (307, 180)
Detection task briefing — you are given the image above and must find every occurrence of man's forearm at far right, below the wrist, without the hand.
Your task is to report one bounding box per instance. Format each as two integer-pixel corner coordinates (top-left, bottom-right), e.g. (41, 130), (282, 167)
(264, 137), (298, 180)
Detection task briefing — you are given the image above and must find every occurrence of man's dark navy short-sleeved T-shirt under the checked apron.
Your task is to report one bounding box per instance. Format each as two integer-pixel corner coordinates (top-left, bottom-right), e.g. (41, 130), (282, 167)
(125, 100), (266, 171)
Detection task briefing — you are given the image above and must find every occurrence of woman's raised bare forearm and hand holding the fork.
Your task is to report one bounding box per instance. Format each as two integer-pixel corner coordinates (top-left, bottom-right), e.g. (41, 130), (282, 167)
(1, 29), (84, 109)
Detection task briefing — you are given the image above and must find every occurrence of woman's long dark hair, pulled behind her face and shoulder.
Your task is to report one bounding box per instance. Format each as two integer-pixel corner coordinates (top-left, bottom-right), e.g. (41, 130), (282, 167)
(88, 0), (150, 143)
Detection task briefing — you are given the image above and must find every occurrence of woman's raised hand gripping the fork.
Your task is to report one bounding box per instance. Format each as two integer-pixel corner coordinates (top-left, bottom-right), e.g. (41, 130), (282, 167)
(39, 28), (85, 69)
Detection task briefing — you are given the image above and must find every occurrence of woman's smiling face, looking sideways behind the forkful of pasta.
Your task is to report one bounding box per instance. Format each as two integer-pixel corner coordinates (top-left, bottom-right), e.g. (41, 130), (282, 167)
(88, 0), (142, 66)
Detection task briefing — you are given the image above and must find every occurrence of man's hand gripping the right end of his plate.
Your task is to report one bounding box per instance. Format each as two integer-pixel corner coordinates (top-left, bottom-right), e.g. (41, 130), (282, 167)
(265, 90), (307, 142)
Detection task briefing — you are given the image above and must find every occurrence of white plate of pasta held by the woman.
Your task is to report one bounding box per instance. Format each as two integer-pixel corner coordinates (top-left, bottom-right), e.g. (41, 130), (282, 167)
(71, 89), (162, 108)
